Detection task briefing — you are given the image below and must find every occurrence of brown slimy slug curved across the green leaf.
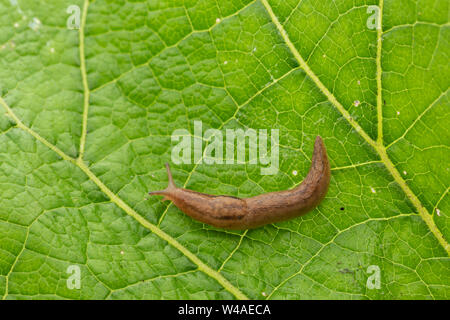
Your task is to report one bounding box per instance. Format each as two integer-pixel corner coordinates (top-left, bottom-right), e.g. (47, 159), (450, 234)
(149, 136), (330, 230)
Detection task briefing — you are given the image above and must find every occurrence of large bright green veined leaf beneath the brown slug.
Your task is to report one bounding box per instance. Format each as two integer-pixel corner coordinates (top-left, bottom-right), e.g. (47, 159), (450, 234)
(0, 0), (450, 299)
